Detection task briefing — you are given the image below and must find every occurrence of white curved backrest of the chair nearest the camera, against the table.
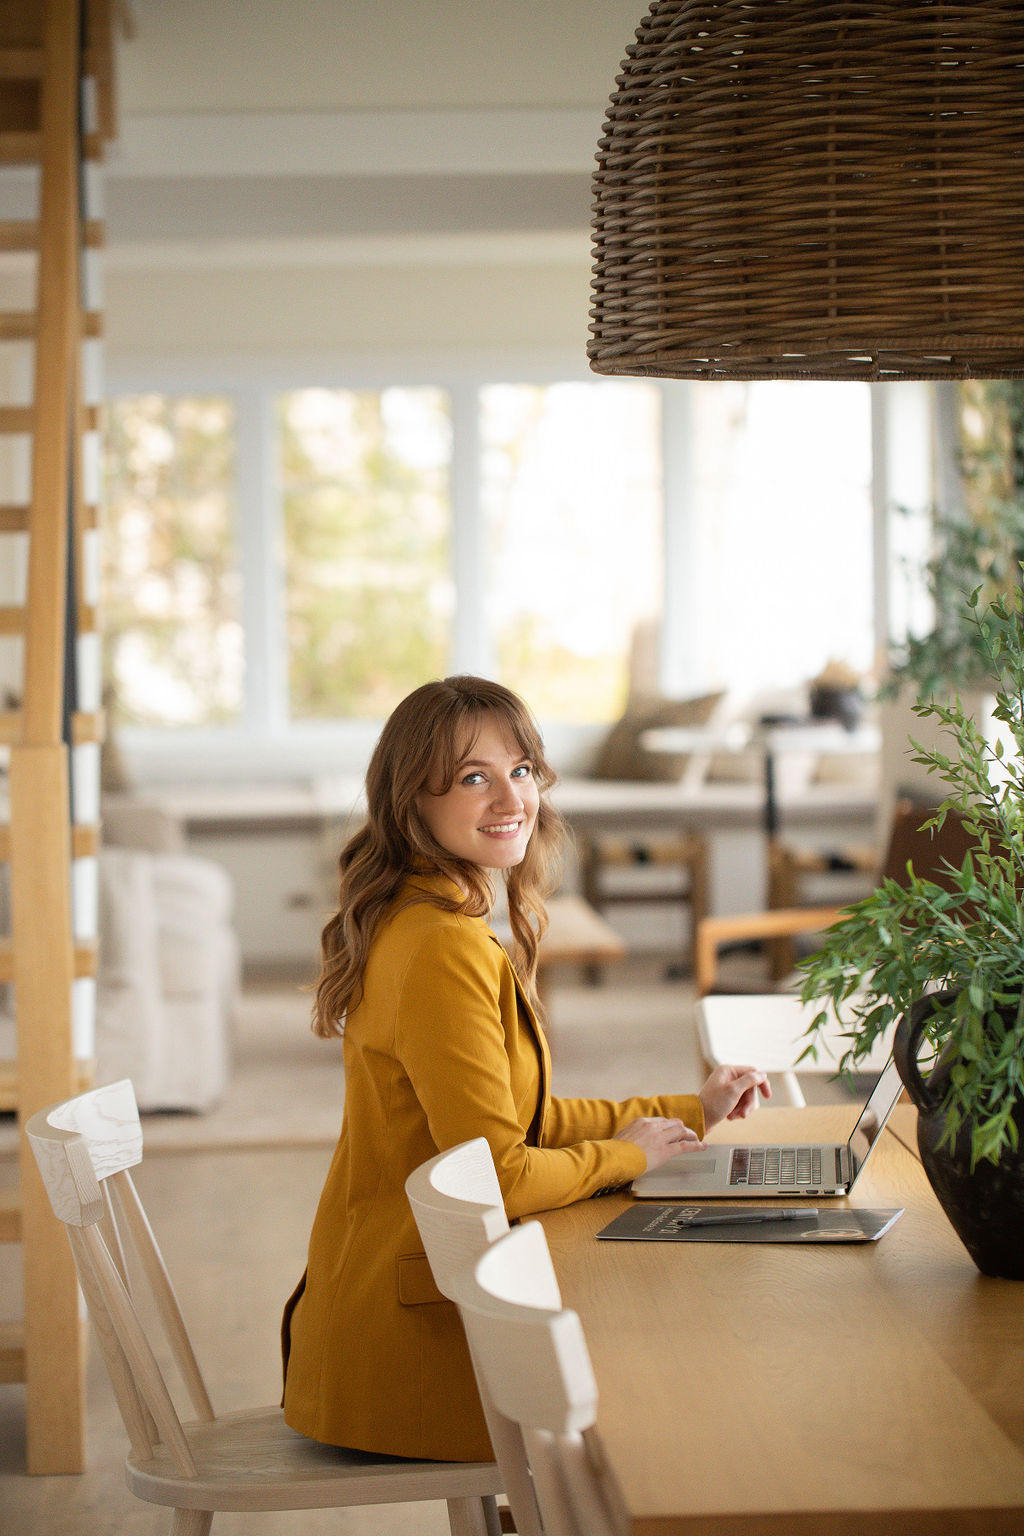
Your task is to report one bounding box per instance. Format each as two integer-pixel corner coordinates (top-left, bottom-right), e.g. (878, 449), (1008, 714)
(461, 1221), (628, 1536)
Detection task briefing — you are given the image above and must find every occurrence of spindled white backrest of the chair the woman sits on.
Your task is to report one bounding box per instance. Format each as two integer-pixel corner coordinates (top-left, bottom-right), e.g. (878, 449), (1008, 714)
(25, 1078), (215, 1478)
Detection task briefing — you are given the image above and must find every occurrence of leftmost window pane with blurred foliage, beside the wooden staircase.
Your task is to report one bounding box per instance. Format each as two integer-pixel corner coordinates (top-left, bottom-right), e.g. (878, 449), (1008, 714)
(103, 395), (243, 727)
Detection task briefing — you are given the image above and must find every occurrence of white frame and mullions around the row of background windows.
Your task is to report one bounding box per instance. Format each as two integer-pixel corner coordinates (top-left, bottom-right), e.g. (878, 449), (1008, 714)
(106, 350), (914, 783)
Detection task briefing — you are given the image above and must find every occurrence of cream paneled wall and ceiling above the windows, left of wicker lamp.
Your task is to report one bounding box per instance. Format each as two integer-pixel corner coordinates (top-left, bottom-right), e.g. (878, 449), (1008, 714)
(104, 0), (642, 370)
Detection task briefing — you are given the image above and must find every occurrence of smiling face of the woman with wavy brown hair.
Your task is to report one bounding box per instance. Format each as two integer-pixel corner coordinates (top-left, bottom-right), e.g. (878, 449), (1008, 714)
(416, 716), (540, 869)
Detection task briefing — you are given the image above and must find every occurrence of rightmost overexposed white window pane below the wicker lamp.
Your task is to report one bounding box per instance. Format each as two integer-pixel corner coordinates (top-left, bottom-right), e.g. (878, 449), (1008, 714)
(691, 381), (874, 693)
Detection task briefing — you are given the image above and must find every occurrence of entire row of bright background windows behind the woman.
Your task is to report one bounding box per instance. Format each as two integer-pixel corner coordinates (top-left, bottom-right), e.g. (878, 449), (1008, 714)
(104, 365), (872, 761)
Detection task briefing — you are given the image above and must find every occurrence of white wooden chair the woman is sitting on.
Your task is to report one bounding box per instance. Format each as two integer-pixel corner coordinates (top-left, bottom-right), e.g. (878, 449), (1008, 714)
(26, 1078), (502, 1536)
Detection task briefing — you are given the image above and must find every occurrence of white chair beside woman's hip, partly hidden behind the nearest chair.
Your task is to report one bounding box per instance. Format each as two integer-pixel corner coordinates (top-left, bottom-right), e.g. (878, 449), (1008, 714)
(405, 1137), (542, 1536)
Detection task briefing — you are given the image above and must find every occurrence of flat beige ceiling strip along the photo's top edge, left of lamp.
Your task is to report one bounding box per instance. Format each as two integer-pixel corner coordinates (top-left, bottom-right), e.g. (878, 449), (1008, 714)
(118, 0), (648, 115)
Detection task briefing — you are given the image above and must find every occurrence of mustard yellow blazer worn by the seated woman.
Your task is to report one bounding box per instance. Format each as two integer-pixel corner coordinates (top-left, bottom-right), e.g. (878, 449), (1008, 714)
(282, 879), (703, 1461)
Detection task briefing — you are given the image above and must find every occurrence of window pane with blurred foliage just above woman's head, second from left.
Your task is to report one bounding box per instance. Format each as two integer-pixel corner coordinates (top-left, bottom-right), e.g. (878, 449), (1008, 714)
(278, 389), (454, 720)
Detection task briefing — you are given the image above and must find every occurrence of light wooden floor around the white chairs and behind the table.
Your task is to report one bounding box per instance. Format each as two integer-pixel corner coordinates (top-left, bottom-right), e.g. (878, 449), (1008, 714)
(0, 963), (853, 1536)
